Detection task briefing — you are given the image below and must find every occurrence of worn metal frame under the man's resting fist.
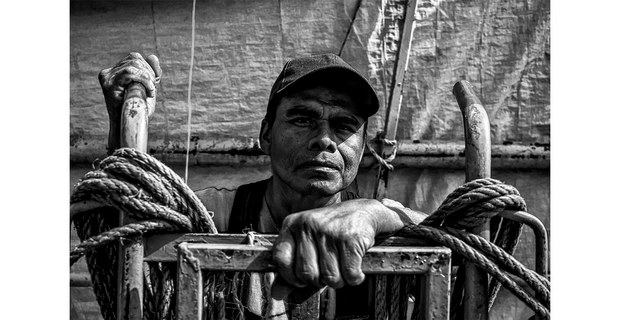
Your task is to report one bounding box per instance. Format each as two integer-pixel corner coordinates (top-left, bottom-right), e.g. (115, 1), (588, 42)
(139, 234), (451, 320)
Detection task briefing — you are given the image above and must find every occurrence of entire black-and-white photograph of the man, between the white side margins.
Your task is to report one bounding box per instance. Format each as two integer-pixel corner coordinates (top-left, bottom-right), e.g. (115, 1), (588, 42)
(65, 0), (551, 320)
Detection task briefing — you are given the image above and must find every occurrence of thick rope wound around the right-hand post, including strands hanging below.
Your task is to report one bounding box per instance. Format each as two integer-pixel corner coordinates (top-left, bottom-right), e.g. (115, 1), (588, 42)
(414, 179), (550, 318)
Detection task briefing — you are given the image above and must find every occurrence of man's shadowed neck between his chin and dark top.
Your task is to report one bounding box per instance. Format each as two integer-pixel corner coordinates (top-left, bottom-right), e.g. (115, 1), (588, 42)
(265, 176), (340, 227)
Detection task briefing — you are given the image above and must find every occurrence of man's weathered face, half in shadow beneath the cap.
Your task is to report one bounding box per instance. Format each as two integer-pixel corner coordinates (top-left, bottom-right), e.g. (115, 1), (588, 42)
(261, 86), (366, 196)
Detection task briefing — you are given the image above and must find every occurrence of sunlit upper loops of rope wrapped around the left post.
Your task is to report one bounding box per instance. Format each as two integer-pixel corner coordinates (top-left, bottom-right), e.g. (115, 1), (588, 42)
(71, 148), (217, 264)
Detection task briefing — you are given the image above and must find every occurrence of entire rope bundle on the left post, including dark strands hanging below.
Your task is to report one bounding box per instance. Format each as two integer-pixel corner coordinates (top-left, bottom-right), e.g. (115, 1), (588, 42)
(70, 148), (217, 319)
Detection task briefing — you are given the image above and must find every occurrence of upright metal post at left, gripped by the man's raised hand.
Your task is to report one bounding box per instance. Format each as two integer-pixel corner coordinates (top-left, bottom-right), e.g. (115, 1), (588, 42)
(116, 82), (149, 320)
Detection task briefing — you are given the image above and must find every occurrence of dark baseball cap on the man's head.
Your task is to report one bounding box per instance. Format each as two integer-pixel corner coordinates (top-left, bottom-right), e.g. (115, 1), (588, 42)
(266, 53), (379, 118)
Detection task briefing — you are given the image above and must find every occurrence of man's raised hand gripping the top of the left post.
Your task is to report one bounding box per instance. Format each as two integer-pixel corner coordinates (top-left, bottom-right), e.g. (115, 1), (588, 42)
(99, 52), (161, 123)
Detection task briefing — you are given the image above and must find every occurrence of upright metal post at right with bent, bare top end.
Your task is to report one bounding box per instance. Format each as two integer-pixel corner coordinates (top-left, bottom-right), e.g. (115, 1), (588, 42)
(452, 80), (491, 320)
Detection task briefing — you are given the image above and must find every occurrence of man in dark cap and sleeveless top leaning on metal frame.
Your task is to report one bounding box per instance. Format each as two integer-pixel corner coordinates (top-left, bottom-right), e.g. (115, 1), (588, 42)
(99, 53), (426, 315)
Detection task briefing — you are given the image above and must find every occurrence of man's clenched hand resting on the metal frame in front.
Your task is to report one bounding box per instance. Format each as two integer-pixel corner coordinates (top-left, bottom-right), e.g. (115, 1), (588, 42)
(272, 199), (404, 299)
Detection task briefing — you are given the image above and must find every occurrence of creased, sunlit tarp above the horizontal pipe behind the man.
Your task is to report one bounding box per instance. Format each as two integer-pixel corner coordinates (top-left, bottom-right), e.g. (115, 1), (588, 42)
(70, 0), (550, 159)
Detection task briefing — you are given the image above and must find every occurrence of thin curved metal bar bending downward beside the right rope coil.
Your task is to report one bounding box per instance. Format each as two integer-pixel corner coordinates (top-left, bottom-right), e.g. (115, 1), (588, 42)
(499, 210), (549, 278)
